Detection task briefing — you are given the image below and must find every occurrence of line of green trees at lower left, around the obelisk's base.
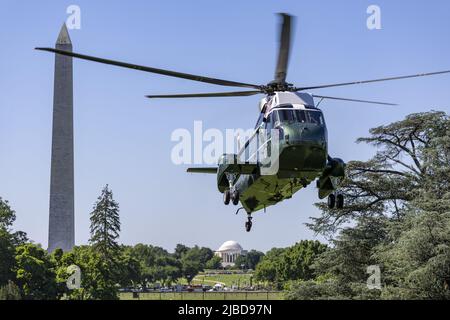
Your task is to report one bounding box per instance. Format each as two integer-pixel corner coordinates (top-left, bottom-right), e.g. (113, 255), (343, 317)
(0, 186), (234, 299)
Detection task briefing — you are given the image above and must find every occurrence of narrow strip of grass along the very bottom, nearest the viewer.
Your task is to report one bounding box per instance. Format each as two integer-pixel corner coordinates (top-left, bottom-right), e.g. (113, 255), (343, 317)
(120, 291), (283, 300)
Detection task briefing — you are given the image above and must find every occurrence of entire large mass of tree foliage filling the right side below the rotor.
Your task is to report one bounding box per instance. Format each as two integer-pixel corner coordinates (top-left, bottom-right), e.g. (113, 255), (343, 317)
(294, 111), (450, 299)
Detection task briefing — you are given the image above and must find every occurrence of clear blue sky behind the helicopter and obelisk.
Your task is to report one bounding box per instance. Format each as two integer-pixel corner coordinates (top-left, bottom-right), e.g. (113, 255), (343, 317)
(0, 0), (450, 250)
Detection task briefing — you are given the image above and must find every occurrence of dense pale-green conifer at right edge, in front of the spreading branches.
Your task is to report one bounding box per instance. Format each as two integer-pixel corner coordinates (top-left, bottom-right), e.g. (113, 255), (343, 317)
(376, 121), (450, 299)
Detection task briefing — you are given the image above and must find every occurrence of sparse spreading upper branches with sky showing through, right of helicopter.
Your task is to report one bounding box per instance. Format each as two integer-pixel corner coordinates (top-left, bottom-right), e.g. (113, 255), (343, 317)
(308, 111), (449, 238)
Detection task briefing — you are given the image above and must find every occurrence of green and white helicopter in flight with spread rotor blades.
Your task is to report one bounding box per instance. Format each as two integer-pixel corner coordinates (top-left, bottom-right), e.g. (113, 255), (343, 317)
(35, 13), (450, 232)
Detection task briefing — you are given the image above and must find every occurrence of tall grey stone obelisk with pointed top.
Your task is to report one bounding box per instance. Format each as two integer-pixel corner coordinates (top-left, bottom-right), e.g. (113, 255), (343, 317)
(48, 24), (75, 252)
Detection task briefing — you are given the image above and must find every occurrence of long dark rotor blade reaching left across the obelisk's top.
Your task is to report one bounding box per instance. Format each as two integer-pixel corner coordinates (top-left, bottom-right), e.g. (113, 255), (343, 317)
(35, 48), (261, 89)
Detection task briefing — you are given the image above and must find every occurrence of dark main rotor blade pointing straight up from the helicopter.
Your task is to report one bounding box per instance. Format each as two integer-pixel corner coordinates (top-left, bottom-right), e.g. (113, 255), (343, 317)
(275, 13), (293, 83)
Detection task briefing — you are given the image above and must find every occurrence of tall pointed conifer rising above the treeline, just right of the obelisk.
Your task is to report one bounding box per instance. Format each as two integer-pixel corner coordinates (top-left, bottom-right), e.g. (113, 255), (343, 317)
(89, 185), (120, 260)
